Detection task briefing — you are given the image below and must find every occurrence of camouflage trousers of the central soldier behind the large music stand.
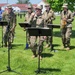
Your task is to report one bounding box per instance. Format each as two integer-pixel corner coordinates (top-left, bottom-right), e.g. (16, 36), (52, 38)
(30, 36), (44, 55)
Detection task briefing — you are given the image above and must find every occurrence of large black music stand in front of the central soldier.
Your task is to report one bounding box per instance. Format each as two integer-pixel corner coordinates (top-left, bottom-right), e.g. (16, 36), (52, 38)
(26, 27), (51, 73)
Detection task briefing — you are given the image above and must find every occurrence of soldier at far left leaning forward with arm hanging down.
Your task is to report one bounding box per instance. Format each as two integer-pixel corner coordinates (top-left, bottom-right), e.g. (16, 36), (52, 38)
(2, 5), (16, 46)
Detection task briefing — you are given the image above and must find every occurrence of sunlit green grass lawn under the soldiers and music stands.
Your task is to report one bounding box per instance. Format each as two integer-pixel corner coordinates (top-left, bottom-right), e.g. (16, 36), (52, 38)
(0, 17), (75, 75)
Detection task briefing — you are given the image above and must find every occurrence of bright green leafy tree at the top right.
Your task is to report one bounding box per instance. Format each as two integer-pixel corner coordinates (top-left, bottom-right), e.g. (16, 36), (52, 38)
(47, 0), (75, 12)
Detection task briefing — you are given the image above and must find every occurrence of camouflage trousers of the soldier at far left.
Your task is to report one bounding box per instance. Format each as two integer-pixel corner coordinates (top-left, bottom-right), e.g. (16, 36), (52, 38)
(3, 26), (14, 45)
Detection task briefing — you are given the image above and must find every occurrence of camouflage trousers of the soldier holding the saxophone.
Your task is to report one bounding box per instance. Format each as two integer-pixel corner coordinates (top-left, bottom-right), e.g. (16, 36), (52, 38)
(61, 27), (72, 47)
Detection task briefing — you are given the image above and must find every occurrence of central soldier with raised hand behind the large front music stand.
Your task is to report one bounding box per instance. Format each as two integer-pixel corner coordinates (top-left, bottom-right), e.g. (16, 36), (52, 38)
(30, 6), (44, 59)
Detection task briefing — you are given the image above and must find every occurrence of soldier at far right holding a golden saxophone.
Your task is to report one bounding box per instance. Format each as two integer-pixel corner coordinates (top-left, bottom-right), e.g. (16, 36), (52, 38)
(61, 4), (74, 50)
